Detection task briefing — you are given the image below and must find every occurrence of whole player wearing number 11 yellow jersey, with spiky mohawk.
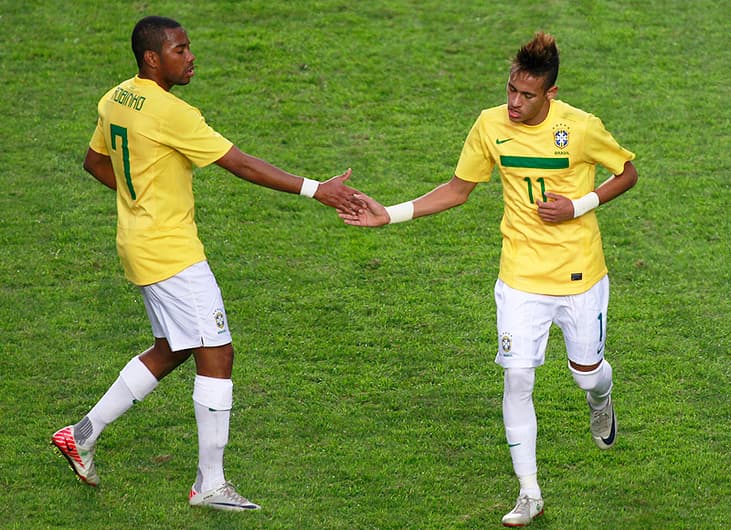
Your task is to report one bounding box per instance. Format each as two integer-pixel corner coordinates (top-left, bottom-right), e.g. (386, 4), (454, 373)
(339, 33), (637, 526)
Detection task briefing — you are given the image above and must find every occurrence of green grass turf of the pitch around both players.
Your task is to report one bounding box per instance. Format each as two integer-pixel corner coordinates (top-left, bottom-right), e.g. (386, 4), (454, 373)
(0, 0), (731, 529)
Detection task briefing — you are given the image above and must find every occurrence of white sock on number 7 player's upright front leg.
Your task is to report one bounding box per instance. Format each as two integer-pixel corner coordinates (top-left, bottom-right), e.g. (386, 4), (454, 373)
(193, 375), (233, 492)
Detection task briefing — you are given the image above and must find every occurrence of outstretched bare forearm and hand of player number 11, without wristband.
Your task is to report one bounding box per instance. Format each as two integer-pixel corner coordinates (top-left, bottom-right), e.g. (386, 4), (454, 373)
(338, 176), (477, 227)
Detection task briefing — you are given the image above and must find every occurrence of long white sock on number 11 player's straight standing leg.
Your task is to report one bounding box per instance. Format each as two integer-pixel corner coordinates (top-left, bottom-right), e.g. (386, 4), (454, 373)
(503, 368), (541, 498)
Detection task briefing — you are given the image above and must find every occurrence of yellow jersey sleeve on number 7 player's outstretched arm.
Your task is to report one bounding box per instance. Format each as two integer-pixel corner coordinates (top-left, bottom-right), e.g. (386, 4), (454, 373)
(165, 104), (233, 167)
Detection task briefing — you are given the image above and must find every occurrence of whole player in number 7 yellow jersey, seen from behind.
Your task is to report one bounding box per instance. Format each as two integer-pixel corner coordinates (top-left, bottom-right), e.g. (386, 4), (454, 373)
(52, 17), (364, 511)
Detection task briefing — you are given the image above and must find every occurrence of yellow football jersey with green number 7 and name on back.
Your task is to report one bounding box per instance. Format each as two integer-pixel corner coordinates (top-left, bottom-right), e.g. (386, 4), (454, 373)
(89, 76), (232, 285)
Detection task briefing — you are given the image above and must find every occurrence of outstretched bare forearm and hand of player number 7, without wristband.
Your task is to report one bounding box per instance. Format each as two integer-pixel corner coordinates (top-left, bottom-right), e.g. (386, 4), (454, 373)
(216, 146), (361, 212)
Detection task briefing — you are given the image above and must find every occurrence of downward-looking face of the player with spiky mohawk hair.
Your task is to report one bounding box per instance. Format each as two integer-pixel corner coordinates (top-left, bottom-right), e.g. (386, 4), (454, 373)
(507, 72), (558, 125)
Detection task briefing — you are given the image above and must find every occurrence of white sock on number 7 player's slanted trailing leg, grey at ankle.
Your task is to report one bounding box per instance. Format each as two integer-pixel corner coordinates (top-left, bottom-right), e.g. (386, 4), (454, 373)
(74, 356), (158, 448)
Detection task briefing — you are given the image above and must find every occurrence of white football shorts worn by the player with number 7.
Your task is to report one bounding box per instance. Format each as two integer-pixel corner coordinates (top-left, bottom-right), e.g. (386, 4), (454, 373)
(140, 261), (231, 351)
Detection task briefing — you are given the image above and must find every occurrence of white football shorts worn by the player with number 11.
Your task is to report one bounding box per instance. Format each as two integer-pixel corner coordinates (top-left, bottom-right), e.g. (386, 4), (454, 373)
(495, 276), (609, 368)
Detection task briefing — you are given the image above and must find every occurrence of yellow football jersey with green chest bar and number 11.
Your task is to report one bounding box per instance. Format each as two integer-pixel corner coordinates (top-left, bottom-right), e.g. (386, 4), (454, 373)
(455, 100), (635, 295)
